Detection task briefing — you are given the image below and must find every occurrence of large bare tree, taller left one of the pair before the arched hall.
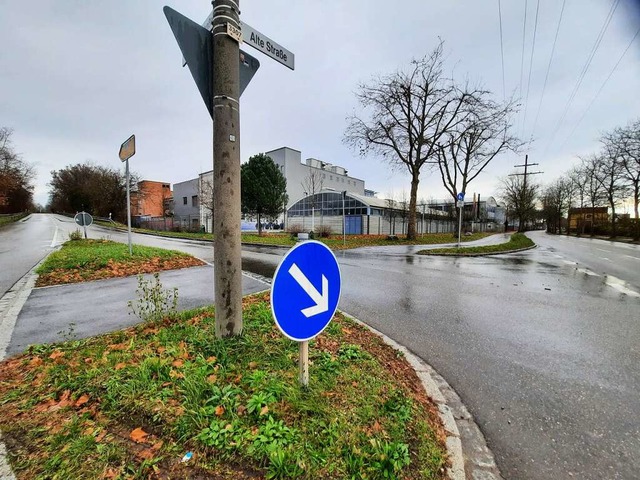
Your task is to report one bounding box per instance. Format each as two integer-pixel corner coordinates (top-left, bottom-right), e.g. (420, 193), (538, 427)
(344, 42), (473, 239)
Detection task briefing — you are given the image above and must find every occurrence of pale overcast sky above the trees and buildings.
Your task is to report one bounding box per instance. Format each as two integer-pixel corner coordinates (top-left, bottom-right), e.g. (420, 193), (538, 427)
(0, 0), (640, 209)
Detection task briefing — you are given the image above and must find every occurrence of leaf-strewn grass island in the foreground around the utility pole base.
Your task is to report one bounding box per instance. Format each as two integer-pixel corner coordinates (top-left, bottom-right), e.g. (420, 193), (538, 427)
(0, 294), (446, 480)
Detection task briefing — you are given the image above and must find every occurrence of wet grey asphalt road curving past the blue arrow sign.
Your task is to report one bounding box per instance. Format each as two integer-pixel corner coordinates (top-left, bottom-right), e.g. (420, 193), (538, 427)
(1, 216), (640, 479)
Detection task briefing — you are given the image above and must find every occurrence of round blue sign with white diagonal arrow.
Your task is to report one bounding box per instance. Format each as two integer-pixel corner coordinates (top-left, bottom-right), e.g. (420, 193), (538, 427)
(271, 240), (342, 342)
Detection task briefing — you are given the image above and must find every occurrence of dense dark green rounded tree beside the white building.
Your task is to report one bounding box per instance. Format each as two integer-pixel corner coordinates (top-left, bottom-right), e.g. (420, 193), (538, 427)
(240, 153), (288, 235)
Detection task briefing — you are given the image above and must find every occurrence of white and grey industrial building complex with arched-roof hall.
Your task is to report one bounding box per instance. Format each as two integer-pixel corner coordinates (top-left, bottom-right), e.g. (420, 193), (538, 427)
(174, 147), (500, 235)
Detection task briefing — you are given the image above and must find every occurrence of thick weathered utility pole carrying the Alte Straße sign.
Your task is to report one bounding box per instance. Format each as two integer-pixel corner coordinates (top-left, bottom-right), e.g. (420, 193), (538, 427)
(211, 0), (242, 338)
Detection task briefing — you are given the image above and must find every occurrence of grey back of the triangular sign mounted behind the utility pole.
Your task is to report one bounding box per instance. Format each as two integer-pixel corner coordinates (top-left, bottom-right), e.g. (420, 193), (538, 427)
(162, 7), (260, 118)
